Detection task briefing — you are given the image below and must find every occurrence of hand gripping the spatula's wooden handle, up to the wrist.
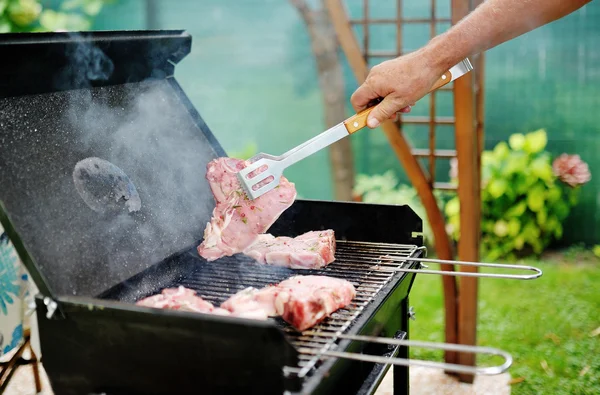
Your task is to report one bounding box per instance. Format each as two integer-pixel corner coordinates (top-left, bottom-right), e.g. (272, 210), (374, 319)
(350, 50), (445, 129)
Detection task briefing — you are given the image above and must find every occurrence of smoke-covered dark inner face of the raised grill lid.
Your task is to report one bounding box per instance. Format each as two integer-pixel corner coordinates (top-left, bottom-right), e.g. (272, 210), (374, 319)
(0, 34), (217, 296)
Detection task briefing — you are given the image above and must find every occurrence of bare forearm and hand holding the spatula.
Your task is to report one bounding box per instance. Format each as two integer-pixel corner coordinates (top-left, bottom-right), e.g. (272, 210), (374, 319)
(350, 0), (591, 128)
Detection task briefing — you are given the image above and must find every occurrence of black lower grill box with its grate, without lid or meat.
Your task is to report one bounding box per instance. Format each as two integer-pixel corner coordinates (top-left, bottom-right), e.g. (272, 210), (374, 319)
(32, 201), (420, 394)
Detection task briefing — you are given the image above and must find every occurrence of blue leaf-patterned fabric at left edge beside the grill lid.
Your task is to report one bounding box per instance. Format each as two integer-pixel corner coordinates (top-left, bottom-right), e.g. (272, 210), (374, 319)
(0, 226), (30, 356)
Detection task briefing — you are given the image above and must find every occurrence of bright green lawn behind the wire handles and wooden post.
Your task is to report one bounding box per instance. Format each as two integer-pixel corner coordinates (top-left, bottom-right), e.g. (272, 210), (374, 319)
(410, 254), (600, 395)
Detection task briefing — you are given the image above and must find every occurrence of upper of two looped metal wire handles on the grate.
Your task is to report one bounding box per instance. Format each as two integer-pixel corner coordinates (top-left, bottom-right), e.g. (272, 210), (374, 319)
(391, 247), (542, 280)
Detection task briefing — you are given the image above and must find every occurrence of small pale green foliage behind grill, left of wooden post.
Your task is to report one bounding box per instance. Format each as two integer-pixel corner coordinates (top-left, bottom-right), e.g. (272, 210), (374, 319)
(354, 170), (444, 247)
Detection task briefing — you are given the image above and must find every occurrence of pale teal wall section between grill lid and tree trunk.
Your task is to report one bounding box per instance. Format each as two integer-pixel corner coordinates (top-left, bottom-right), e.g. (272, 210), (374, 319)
(95, 0), (332, 199)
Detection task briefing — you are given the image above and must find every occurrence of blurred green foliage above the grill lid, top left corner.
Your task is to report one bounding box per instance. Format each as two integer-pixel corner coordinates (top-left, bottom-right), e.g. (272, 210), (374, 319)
(0, 0), (114, 33)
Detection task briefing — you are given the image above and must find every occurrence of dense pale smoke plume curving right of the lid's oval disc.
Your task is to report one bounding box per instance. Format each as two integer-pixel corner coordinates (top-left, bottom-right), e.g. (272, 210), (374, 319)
(62, 86), (214, 296)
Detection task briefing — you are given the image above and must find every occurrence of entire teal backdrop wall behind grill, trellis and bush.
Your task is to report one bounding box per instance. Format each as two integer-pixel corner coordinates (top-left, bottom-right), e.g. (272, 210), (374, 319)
(94, 0), (600, 243)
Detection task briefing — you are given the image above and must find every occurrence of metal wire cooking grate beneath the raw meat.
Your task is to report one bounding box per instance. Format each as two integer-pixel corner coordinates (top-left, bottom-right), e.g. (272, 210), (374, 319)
(98, 240), (421, 387)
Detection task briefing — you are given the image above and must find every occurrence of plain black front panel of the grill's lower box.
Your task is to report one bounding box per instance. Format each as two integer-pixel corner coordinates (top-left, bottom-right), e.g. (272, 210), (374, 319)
(37, 298), (295, 395)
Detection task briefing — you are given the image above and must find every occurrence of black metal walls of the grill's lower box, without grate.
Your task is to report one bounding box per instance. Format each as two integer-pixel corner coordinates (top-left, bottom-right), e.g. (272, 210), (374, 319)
(0, 200), (423, 394)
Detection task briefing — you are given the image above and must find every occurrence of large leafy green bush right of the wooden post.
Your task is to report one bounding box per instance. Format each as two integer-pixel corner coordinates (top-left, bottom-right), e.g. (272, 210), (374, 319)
(445, 129), (579, 261)
